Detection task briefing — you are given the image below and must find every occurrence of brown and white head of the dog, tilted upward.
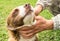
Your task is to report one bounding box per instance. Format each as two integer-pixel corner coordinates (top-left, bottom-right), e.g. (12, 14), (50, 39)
(7, 4), (33, 28)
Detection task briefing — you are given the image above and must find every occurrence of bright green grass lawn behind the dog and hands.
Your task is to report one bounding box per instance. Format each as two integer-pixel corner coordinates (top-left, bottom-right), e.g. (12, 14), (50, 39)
(0, 0), (60, 41)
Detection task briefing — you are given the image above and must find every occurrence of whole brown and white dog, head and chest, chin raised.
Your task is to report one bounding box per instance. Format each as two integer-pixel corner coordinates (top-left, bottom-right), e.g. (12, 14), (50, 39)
(7, 4), (37, 41)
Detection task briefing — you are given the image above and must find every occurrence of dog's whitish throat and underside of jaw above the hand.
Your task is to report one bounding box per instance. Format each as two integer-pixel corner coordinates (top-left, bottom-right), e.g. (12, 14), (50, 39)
(23, 13), (35, 25)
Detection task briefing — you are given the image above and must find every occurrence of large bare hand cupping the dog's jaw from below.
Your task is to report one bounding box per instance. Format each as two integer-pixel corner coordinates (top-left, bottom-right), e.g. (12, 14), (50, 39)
(20, 16), (52, 38)
